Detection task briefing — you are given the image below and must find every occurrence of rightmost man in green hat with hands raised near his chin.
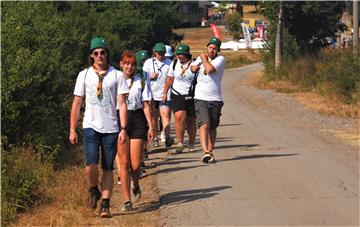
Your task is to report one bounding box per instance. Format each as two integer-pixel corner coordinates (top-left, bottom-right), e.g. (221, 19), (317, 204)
(191, 37), (225, 163)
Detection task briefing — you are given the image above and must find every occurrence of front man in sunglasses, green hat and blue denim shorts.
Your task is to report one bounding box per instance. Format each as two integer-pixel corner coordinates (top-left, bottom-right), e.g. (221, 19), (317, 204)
(69, 37), (129, 218)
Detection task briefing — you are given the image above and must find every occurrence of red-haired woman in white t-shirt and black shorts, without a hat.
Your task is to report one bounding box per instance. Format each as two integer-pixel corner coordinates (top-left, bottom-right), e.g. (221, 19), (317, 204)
(118, 51), (154, 211)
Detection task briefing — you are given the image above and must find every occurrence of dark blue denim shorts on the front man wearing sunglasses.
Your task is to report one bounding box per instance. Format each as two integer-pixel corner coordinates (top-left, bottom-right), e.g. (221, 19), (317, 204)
(84, 128), (119, 171)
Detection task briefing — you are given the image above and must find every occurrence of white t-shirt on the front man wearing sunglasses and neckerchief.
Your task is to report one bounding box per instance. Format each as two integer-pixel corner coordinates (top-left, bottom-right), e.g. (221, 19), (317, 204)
(74, 67), (129, 133)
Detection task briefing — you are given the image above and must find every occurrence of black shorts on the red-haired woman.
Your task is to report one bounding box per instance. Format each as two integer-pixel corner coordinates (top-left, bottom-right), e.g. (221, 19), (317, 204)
(119, 109), (149, 140)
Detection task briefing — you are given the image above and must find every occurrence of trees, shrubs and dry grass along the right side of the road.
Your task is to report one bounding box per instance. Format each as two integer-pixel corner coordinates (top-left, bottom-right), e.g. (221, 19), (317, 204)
(260, 2), (360, 117)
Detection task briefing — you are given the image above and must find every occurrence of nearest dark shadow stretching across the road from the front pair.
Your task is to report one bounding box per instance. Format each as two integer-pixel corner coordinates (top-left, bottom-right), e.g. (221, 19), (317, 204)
(160, 186), (231, 206)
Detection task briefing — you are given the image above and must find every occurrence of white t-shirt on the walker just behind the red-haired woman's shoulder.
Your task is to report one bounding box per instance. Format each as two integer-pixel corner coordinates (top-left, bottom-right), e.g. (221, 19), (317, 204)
(143, 57), (171, 101)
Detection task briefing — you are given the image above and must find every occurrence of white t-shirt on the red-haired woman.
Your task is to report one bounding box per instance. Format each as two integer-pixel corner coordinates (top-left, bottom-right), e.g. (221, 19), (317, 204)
(126, 74), (152, 110)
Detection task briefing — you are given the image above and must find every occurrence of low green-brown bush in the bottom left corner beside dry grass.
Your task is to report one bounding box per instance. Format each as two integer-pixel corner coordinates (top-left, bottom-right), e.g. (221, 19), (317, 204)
(1, 147), (53, 226)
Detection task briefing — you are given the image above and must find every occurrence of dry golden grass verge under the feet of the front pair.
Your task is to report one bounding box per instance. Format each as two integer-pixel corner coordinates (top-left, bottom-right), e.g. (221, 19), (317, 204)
(13, 164), (159, 226)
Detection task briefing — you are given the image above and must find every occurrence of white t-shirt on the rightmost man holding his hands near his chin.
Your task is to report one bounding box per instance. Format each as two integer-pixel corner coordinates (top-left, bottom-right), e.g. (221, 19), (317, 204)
(192, 55), (225, 101)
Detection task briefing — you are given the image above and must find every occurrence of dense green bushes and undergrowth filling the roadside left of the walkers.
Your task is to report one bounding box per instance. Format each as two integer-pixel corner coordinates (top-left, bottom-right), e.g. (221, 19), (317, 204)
(1, 1), (180, 226)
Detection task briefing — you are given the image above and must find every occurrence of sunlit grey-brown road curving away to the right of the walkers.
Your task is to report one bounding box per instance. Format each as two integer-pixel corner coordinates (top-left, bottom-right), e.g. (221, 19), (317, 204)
(152, 64), (359, 226)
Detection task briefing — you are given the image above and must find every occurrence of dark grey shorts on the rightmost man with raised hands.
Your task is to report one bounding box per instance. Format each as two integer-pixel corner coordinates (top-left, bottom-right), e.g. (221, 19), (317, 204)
(194, 99), (224, 129)
